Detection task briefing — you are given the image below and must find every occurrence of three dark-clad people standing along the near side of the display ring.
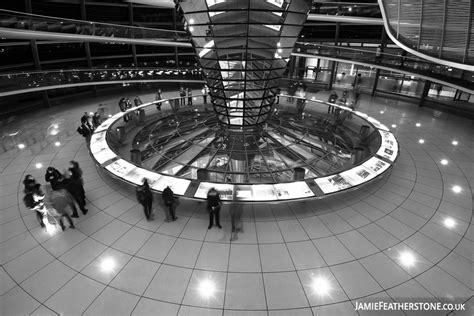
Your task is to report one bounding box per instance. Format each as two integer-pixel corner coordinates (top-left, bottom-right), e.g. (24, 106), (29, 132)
(136, 178), (222, 229)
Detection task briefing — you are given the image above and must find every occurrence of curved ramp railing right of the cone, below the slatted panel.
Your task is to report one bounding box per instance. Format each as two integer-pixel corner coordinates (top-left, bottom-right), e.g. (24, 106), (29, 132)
(293, 43), (474, 94)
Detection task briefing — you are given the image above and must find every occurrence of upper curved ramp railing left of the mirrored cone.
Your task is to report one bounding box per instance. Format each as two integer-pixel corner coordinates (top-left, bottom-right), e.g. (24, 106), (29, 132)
(0, 10), (191, 47)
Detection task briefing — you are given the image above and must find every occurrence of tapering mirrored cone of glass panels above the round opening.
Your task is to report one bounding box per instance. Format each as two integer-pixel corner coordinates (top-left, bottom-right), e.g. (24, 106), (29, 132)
(179, 0), (311, 126)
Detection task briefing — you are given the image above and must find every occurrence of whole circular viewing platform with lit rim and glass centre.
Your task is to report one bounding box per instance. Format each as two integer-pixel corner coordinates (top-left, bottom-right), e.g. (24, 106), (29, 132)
(89, 95), (399, 202)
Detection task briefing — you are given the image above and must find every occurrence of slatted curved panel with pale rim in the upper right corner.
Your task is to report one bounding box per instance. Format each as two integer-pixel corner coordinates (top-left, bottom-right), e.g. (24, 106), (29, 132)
(378, 0), (474, 71)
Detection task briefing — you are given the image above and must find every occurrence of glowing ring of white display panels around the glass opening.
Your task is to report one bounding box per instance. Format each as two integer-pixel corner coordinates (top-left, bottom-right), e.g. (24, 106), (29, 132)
(90, 99), (399, 201)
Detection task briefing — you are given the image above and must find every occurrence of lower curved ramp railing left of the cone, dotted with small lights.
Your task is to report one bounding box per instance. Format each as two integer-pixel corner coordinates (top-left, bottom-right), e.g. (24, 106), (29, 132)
(0, 68), (203, 97)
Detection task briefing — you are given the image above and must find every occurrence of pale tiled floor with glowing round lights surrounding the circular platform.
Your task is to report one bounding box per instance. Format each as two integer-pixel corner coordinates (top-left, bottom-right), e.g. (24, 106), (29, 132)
(0, 91), (474, 315)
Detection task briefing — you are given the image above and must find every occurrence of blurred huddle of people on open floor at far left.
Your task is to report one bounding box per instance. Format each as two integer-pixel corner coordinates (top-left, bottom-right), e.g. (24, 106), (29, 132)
(23, 161), (88, 230)
